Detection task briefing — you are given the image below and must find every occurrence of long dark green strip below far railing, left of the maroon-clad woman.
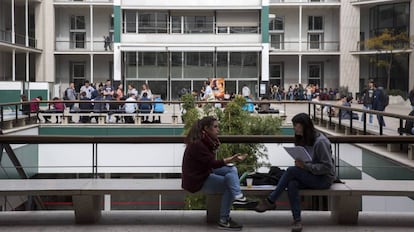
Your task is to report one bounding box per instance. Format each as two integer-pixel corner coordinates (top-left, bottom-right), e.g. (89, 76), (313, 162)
(39, 126), (183, 136)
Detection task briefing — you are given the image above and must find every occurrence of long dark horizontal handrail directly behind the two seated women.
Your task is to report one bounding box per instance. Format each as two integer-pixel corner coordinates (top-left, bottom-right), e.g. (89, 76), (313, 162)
(0, 135), (414, 144)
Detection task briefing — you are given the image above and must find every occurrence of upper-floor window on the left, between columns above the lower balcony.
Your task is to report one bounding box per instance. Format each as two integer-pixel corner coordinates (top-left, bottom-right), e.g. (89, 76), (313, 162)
(69, 15), (86, 48)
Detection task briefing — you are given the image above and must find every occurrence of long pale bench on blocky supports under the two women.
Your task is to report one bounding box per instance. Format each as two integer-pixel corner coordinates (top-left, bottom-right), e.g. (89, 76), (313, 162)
(0, 179), (414, 224)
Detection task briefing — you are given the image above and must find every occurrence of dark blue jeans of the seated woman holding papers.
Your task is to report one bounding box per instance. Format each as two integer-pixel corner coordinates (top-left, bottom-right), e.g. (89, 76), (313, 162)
(268, 166), (331, 221)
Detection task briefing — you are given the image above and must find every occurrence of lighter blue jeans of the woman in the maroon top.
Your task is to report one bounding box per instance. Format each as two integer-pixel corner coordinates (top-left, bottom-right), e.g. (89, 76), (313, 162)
(201, 166), (242, 220)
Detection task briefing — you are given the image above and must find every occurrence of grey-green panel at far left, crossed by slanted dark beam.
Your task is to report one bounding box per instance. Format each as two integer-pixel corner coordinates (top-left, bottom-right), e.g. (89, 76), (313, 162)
(0, 144), (39, 179)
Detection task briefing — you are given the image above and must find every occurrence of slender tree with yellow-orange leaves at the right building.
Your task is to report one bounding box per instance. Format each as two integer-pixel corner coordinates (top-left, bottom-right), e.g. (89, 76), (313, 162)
(364, 29), (413, 90)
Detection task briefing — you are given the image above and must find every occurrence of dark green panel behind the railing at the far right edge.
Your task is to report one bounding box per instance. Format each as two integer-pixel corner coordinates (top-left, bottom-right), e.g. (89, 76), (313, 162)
(362, 150), (414, 180)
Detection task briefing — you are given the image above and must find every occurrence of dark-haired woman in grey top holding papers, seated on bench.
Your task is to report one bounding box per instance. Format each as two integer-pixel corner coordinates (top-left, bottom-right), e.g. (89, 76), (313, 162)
(256, 113), (336, 231)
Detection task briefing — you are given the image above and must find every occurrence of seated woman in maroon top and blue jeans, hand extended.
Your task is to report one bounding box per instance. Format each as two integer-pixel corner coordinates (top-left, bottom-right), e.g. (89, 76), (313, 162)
(181, 116), (257, 230)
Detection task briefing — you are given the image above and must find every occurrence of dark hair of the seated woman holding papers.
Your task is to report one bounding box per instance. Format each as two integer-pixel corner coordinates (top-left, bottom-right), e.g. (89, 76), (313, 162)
(292, 113), (319, 146)
